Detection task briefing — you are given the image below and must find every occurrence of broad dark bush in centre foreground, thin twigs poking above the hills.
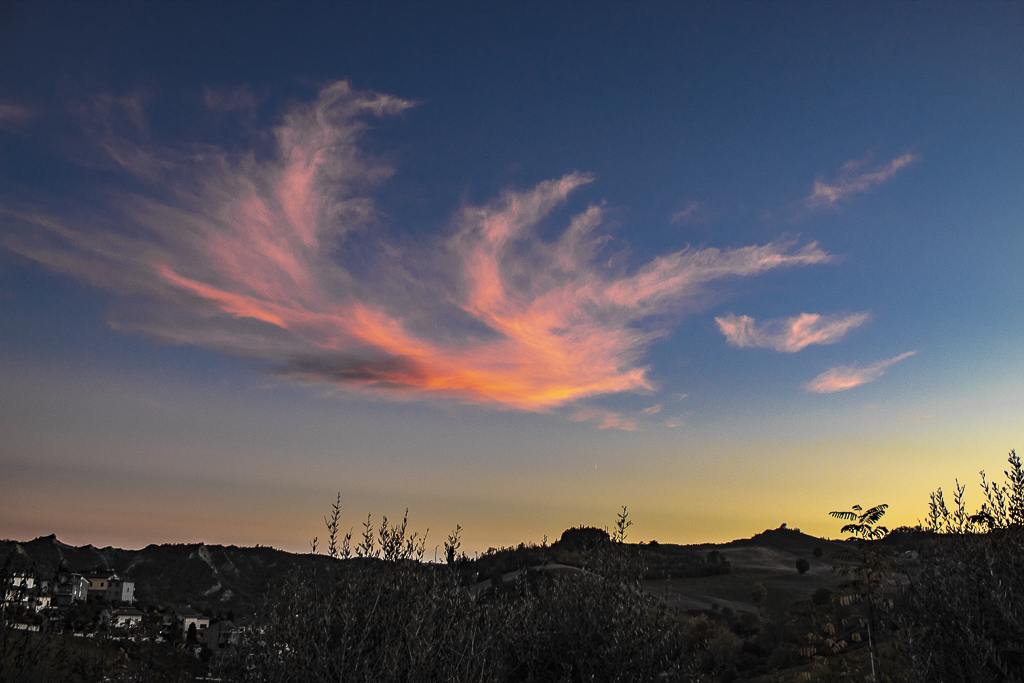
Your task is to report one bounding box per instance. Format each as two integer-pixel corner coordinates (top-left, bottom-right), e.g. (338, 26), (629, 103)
(221, 507), (702, 682)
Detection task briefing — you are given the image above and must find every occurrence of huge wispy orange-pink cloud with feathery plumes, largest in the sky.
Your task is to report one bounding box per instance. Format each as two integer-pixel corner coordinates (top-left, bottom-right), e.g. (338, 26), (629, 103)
(2, 82), (831, 411)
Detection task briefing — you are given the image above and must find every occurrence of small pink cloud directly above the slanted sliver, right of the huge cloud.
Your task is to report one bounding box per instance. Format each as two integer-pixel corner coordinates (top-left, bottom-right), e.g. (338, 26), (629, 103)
(715, 311), (870, 353)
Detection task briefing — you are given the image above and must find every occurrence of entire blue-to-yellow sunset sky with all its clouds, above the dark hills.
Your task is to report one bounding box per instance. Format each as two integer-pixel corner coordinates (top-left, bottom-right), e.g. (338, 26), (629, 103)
(0, 1), (1024, 559)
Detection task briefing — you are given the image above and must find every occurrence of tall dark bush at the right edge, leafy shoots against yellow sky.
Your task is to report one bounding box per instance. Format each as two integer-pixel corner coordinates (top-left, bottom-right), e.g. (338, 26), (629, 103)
(895, 451), (1024, 682)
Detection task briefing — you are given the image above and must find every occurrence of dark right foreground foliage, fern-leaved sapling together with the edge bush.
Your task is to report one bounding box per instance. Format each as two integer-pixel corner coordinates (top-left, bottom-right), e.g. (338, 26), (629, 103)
(799, 451), (1024, 683)
